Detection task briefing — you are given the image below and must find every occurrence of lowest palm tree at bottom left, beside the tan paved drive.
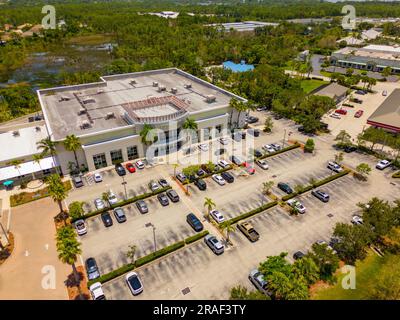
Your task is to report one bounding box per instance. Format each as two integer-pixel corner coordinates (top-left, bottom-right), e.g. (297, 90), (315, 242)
(56, 226), (82, 298)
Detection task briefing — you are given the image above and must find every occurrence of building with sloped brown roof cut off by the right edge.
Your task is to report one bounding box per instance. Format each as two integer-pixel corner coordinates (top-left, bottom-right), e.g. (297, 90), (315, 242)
(367, 89), (400, 133)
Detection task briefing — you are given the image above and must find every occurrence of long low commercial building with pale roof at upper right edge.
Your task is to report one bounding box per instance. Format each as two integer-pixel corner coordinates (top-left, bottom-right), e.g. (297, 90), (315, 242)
(330, 45), (400, 74)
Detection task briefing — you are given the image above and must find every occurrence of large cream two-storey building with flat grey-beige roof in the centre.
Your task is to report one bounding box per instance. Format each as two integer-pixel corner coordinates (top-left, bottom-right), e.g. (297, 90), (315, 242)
(38, 68), (246, 173)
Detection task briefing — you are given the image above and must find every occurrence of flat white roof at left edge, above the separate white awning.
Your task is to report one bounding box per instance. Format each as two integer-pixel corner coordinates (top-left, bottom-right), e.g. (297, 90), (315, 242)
(0, 126), (47, 162)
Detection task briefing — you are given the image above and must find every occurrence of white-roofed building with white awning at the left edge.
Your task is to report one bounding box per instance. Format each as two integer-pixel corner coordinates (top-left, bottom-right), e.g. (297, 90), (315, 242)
(0, 126), (55, 184)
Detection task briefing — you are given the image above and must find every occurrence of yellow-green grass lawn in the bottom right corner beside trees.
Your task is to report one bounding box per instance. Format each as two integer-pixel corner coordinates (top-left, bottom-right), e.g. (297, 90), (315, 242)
(311, 251), (385, 300)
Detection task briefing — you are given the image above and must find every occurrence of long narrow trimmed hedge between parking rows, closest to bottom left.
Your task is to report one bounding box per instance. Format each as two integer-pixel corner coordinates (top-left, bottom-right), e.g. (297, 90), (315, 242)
(87, 230), (209, 287)
